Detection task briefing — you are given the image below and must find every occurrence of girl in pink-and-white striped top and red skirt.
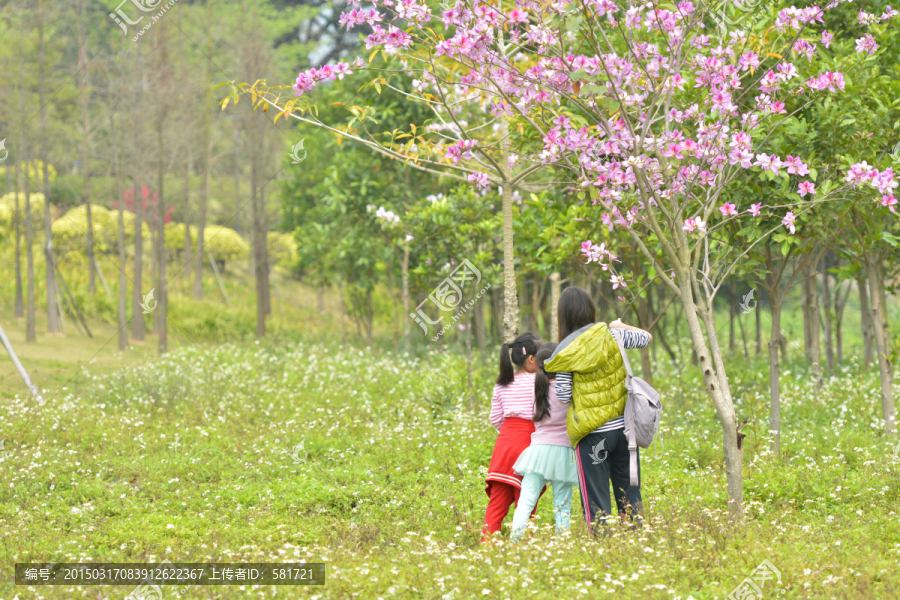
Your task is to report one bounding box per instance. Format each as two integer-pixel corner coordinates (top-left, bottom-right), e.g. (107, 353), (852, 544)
(481, 333), (540, 541)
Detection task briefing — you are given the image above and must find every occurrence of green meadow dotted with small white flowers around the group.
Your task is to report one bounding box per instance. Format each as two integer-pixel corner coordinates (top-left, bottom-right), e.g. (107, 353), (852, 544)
(0, 328), (900, 600)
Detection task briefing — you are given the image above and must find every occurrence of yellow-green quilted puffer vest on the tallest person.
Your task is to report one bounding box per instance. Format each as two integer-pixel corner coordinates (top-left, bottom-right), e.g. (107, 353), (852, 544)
(544, 323), (628, 447)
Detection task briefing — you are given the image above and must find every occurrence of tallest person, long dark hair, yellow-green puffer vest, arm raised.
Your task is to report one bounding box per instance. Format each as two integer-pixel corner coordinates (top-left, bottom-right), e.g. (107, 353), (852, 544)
(545, 287), (653, 527)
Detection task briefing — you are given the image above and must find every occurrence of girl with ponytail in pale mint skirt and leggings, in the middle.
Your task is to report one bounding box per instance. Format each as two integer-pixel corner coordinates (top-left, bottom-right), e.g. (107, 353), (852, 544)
(510, 343), (578, 542)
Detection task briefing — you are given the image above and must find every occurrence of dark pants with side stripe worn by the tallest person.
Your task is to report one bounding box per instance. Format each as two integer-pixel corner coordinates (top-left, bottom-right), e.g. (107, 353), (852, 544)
(575, 429), (642, 527)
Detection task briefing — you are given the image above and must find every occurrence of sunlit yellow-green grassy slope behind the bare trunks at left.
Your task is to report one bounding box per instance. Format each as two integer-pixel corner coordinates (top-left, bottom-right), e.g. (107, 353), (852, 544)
(0, 248), (349, 398)
